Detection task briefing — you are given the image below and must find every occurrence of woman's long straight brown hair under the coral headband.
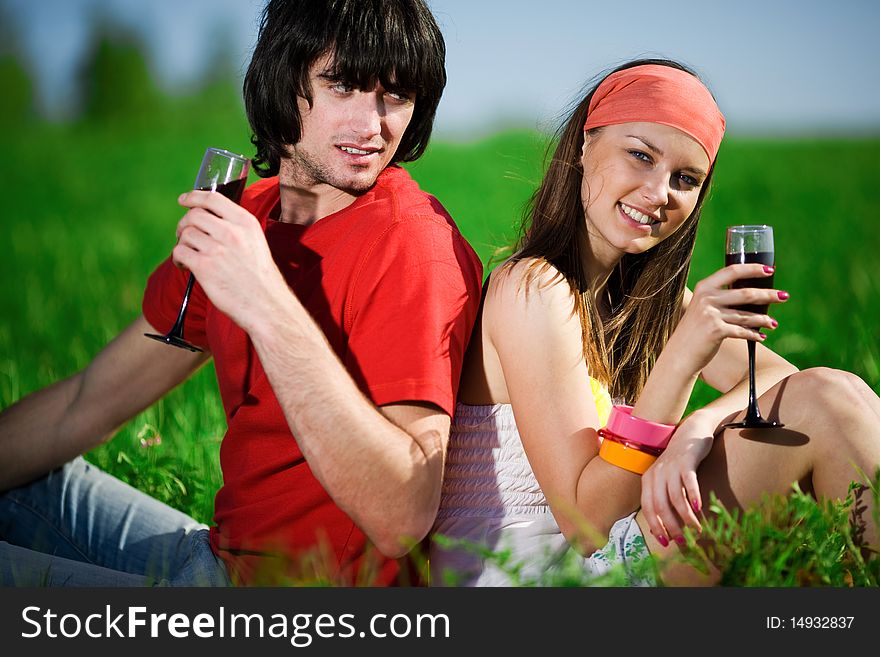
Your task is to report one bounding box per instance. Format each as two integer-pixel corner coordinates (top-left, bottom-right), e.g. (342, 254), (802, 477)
(502, 59), (714, 403)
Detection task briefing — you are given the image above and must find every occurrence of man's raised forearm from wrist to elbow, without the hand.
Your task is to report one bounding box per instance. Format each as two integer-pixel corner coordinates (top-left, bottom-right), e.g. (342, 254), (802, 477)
(249, 295), (448, 555)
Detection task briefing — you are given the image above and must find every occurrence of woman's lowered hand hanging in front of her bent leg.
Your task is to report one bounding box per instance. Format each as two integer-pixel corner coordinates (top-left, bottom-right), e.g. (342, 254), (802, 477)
(642, 411), (717, 545)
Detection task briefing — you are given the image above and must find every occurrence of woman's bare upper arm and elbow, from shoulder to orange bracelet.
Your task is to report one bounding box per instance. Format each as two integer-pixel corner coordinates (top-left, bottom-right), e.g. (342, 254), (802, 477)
(483, 262), (641, 554)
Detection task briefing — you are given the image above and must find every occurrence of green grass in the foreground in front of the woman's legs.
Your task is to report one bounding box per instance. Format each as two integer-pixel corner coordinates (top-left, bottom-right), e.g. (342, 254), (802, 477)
(436, 470), (880, 587)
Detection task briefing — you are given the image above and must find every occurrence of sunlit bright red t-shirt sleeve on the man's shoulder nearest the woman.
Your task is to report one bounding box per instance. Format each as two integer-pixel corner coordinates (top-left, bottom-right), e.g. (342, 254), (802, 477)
(343, 217), (482, 416)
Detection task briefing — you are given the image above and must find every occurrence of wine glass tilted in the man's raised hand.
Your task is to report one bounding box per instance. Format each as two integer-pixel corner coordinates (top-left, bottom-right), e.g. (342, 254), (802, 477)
(144, 148), (250, 351)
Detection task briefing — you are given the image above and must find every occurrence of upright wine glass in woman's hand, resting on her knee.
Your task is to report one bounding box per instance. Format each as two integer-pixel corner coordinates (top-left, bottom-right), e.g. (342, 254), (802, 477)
(724, 225), (784, 429)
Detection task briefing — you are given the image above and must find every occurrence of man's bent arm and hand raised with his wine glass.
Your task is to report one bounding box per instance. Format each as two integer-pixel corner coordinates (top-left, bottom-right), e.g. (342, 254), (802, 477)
(173, 192), (464, 557)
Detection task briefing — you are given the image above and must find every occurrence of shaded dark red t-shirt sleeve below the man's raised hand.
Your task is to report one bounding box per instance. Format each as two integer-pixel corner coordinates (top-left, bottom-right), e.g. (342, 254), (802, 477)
(141, 256), (209, 350)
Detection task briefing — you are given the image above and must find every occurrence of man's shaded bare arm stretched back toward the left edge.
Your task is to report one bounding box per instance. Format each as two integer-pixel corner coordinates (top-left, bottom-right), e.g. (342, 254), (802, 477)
(0, 316), (210, 490)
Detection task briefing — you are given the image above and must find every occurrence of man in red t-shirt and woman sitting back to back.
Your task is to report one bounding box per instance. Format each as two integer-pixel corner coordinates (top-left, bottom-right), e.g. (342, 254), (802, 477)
(0, 0), (880, 586)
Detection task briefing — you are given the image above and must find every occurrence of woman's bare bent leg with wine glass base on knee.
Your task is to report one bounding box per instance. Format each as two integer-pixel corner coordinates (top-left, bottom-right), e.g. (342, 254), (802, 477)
(637, 368), (880, 585)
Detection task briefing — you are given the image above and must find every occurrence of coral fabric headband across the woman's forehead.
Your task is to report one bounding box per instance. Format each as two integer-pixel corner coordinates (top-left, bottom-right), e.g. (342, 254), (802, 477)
(584, 64), (725, 163)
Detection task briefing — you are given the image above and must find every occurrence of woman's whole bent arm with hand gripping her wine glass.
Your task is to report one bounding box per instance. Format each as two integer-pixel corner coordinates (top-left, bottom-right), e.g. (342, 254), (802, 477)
(483, 262), (792, 551)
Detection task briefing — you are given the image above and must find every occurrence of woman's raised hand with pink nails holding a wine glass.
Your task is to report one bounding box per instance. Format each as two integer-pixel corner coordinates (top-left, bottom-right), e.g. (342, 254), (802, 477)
(667, 264), (788, 372)
